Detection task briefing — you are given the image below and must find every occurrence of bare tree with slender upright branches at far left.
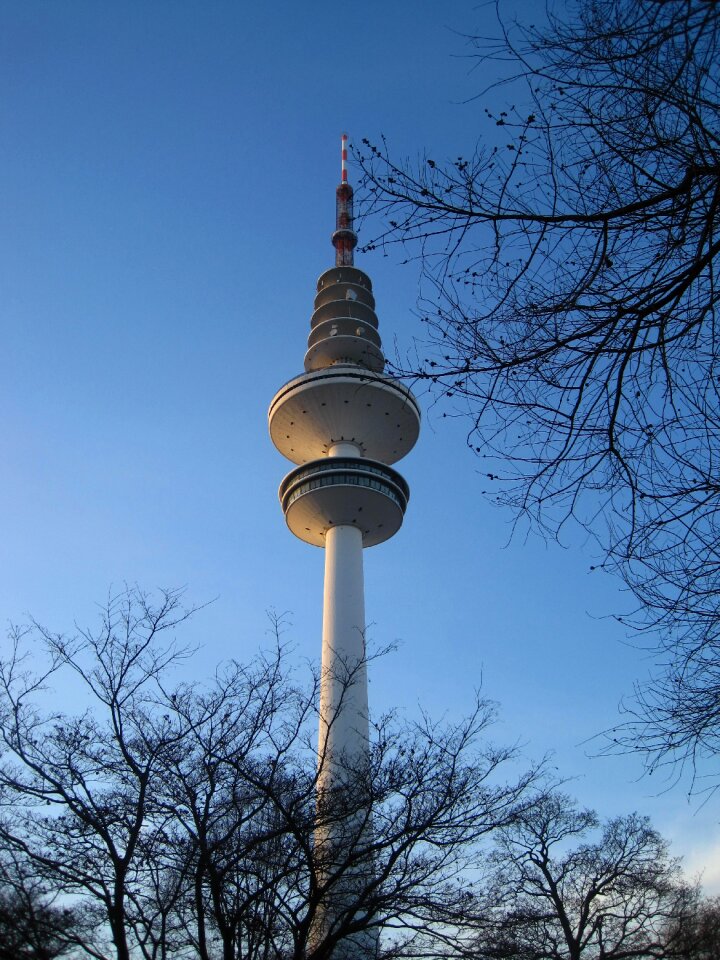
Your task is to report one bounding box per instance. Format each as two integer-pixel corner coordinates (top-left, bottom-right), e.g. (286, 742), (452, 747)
(0, 590), (195, 960)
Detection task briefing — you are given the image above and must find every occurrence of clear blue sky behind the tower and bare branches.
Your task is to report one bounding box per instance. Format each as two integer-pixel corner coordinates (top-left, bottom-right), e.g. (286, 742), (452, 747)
(0, 0), (720, 893)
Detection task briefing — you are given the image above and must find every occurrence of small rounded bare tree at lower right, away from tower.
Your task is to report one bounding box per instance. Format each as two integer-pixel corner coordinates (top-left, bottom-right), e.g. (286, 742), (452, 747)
(475, 794), (694, 960)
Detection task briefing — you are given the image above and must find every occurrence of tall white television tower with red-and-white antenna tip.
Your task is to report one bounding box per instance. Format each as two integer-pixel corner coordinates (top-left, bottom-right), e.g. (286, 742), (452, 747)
(268, 135), (420, 944)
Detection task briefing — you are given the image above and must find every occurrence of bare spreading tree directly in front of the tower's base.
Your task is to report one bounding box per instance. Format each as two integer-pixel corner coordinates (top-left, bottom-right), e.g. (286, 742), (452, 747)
(150, 660), (536, 960)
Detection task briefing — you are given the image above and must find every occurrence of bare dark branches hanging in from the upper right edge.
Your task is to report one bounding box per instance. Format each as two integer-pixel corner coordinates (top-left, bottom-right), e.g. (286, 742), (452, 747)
(357, 0), (720, 788)
